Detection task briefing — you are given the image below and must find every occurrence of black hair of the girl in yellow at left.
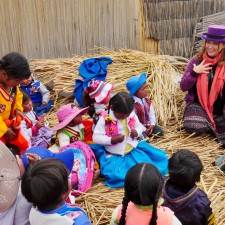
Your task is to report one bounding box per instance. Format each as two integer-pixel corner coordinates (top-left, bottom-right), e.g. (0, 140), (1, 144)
(0, 52), (31, 79)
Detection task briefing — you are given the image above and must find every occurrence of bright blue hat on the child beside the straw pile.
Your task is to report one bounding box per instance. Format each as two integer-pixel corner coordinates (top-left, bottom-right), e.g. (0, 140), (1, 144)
(126, 73), (147, 95)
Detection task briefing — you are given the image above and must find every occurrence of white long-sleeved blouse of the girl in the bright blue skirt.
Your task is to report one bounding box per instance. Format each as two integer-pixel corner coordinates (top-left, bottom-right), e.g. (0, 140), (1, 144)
(93, 110), (145, 155)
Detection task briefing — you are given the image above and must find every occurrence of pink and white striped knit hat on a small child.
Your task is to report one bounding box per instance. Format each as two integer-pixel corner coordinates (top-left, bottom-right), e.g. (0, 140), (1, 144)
(87, 80), (113, 104)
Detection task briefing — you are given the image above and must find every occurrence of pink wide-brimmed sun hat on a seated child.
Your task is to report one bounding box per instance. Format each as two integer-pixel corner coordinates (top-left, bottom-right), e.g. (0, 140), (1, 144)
(53, 104), (88, 131)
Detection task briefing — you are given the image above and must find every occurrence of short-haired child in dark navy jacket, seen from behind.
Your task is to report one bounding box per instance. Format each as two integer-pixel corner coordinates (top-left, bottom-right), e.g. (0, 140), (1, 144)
(163, 149), (217, 225)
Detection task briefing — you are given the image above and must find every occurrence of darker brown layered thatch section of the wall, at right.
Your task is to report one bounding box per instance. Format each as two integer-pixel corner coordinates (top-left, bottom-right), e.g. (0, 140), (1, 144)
(143, 0), (225, 58)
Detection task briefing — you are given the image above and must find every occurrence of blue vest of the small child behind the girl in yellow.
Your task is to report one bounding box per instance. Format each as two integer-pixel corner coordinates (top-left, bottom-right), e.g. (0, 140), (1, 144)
(20, 80), (42, 104)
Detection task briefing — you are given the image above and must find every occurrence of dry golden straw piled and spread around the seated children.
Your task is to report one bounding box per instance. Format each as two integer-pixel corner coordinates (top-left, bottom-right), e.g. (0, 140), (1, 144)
(31, 49), (225, 225)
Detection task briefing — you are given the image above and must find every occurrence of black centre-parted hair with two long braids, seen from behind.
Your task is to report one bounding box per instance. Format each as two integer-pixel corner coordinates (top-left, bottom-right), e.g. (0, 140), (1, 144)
(119, 163), (163, 225)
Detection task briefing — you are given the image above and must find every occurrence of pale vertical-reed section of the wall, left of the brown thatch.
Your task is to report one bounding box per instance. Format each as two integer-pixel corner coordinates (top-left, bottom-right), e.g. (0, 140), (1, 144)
(0, 0), (158, 58)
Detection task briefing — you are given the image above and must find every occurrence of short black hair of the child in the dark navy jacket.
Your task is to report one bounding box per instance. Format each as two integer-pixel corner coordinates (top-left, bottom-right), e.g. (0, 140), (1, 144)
(168, 149), (203, 188)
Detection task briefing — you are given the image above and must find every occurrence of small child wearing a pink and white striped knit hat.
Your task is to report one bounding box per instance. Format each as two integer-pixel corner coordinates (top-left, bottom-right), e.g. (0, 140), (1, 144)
(82, 80), (113, 126)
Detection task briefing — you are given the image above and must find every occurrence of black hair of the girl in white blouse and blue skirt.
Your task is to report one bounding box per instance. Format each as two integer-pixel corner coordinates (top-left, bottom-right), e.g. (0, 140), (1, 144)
(108, 92), (134, 114)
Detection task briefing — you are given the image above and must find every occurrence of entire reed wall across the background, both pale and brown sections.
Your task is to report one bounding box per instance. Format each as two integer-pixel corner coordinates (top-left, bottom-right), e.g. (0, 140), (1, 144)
(0, 0), (225, 58)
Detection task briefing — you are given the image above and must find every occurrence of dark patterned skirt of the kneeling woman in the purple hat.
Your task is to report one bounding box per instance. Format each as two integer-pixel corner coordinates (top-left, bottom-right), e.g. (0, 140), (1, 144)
(184, 103), (225, 145)
